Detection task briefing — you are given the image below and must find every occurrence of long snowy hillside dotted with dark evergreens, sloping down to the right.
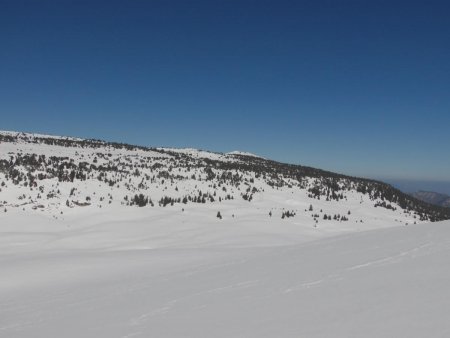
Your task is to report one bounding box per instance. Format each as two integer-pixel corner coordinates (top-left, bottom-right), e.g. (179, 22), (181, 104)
(0, 131), (450, 224)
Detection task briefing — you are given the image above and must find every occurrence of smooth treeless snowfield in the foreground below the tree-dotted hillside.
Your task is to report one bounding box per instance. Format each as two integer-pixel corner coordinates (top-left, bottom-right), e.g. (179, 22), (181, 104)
(0, 209), (450, 338)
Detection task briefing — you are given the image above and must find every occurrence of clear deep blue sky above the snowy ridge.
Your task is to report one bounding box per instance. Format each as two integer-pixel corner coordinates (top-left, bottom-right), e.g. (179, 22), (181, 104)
(0, 0), (450, 181)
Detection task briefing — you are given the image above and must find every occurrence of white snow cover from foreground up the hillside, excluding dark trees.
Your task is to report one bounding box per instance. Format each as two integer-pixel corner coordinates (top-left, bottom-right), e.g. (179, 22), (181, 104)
(0, 133), (450, 338)
